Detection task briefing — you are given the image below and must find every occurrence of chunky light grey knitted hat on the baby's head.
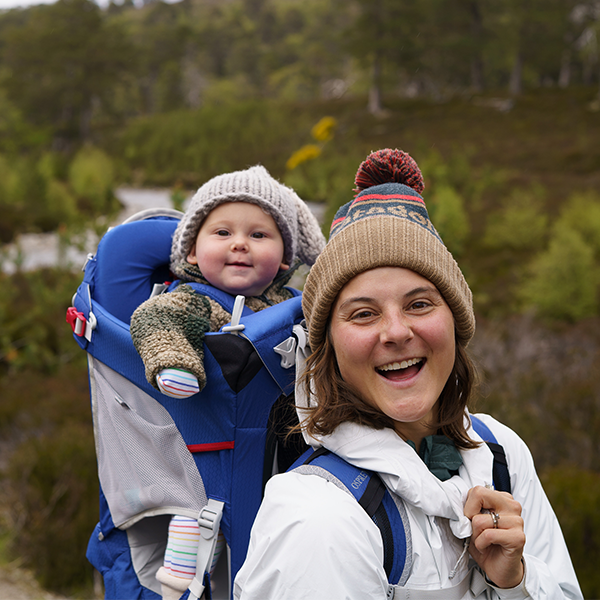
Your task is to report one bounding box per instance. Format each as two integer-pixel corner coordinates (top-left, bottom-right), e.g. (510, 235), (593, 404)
(171, 165), (325, 278)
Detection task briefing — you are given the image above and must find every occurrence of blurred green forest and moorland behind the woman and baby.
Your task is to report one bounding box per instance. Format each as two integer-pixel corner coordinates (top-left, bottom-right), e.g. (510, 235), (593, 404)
(0, 0), (600, 598)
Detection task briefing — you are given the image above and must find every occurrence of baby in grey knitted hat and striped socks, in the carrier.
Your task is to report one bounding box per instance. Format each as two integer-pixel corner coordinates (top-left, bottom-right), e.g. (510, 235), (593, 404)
(131, 166), (325, 599)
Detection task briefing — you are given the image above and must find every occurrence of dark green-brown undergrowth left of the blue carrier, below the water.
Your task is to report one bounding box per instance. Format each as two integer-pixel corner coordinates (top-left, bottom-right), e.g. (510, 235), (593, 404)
(0, 270), (98, 597)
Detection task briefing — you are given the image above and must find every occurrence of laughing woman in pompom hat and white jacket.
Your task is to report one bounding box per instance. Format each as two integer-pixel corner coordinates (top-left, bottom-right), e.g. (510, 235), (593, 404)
(234, 150), (581, 600)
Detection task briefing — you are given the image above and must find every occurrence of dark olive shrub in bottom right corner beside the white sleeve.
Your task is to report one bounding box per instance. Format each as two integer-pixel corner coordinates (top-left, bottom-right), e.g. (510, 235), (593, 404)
(541, 466), (600, 598)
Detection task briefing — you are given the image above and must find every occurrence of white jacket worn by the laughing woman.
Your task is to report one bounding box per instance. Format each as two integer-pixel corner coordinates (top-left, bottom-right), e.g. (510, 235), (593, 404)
(234, 415), (582, 600)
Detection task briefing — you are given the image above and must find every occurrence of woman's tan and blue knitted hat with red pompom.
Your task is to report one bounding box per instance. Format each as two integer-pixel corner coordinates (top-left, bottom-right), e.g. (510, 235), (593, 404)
(302, 149), (475, 350)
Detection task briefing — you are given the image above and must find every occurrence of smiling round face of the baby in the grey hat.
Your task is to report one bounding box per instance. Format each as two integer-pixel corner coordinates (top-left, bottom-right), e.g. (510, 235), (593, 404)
(187, 202), (289, 296)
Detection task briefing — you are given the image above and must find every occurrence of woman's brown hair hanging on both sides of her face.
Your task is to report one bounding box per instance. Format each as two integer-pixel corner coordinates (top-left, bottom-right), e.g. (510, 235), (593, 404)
(301, 327), (479, 449)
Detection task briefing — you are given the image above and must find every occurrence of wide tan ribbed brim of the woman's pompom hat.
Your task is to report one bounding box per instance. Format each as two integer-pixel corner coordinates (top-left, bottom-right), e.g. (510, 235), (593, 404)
(302, 215), (475, 349)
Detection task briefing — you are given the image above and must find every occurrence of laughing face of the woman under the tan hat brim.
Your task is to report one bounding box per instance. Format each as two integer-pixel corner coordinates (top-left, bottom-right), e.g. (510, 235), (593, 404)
(331, 267), (455, 446)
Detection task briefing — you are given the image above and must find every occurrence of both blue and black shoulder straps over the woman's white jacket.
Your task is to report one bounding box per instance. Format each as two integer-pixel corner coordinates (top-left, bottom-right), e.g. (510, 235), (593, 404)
(290, 415), (511, 586)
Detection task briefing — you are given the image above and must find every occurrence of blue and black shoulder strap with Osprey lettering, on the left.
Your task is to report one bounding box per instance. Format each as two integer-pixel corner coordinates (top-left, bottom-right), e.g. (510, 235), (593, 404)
(290, 448), (412, 585)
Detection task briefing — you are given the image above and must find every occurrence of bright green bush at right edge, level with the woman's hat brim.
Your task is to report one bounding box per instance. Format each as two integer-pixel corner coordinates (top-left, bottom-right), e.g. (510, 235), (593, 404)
(518, 224), (600, 322)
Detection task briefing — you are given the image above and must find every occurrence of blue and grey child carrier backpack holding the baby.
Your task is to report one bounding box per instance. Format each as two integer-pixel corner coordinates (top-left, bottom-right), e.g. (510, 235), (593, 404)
(67, 209), (306, 600)
